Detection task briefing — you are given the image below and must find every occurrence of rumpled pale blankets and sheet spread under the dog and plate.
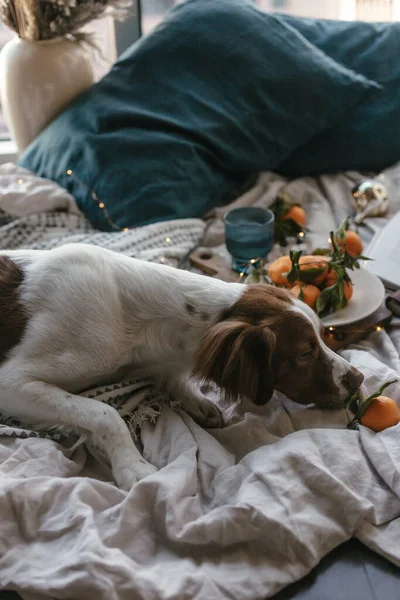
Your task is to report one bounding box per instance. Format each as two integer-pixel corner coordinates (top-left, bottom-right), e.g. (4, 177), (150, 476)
(0, 164), (400, 600)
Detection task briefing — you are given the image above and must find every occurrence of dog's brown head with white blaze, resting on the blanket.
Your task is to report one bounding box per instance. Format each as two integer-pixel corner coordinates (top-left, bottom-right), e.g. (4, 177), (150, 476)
(194, 285), (363, 407)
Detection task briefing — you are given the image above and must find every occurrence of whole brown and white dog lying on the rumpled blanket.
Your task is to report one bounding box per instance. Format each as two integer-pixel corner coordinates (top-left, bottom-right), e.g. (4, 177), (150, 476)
(0, 244), (363, 490)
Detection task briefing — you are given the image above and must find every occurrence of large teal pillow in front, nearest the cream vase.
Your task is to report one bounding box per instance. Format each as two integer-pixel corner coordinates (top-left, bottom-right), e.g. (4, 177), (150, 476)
(19, 0), (379, 230)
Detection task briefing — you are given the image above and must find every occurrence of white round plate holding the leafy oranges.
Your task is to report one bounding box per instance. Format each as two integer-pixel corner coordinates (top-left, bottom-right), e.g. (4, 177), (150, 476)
(321, 269), (385, 327)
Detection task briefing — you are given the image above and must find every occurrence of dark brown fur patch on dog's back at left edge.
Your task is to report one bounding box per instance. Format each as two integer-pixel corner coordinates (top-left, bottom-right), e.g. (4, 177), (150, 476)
(0, 256), (27, 363)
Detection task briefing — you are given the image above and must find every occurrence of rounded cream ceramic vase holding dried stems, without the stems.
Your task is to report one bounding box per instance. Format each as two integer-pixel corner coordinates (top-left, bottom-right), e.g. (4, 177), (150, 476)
(0, 37), (94, 154)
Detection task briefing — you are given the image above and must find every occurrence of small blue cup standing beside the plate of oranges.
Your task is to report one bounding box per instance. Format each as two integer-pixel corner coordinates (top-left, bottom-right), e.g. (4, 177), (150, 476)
(224, 206), (275, 273)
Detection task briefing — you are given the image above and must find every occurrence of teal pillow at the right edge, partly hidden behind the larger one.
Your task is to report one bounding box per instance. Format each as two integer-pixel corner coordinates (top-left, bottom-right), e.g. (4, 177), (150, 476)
(278, 16), (400, 176)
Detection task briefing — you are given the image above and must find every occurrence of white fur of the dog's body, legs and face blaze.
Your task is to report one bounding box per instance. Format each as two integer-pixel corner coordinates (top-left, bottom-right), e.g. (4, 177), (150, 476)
(0, 244), (362, 490)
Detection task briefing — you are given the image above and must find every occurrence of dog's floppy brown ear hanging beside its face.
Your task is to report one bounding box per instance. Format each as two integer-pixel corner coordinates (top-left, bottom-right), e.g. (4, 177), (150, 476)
(193, 320), (275, 405)
